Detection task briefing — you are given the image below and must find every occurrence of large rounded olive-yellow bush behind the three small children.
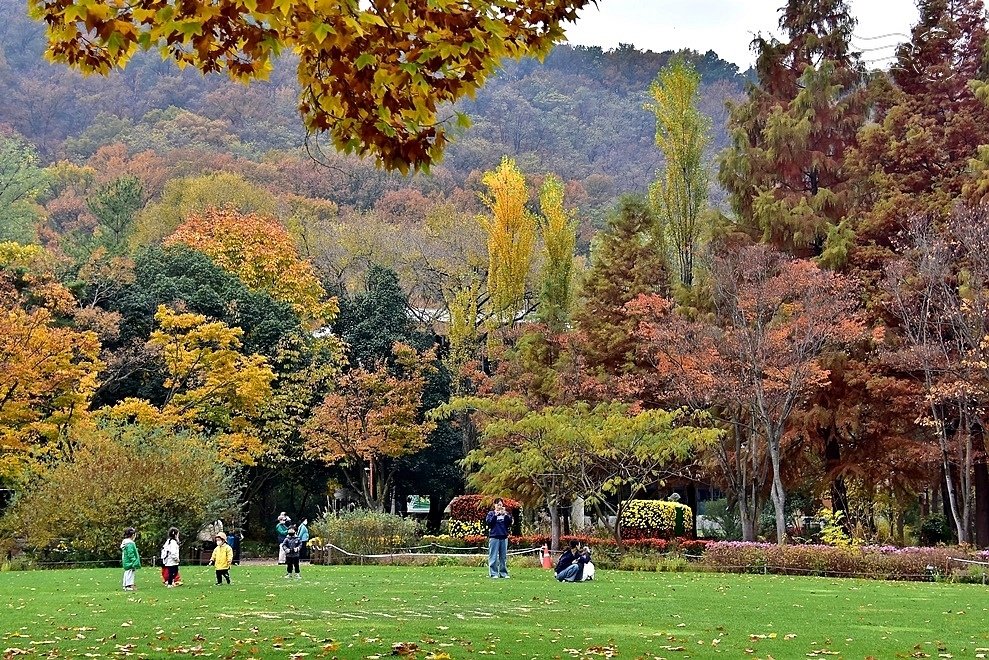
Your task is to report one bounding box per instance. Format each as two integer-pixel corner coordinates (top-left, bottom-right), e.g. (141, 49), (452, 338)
(0, 424), (238, 562)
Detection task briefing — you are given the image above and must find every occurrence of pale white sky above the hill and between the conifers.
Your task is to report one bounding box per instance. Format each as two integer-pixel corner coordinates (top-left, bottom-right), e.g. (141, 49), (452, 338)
(567, 0), (917, 70)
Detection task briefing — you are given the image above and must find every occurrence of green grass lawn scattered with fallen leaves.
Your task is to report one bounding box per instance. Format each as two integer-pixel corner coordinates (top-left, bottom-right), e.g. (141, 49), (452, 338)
(0, 566), (989, 659)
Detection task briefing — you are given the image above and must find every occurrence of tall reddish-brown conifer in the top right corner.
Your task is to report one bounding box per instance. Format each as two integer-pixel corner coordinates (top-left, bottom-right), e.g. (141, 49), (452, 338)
(847, 0), (989, 272)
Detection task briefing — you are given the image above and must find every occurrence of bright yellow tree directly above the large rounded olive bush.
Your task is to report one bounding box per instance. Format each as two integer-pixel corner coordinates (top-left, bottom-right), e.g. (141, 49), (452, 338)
(101, 306), (275, 465)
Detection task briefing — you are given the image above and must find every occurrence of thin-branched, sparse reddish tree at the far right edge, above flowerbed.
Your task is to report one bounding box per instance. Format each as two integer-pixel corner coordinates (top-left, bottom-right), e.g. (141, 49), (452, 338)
(885, 209), (989, 543)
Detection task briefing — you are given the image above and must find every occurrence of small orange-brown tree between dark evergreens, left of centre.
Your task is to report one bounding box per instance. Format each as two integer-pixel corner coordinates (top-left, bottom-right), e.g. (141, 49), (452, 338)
(304, 344), (435, 511)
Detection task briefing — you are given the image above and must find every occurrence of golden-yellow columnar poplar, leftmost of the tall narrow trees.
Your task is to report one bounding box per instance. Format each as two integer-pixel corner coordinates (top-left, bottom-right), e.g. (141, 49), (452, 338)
(478, 157), (537, 324)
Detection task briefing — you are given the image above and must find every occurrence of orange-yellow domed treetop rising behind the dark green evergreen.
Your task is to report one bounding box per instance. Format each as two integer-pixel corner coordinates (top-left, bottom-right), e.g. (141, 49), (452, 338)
(165, 209), (339, 328)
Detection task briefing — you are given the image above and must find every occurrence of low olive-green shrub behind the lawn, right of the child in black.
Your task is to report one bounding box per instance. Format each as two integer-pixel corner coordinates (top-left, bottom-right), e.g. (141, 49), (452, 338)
(310, 510), (420, 563)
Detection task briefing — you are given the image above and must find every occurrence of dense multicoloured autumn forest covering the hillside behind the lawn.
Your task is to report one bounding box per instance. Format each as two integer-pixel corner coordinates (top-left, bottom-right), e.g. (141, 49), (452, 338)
(0, 0), (989, 554)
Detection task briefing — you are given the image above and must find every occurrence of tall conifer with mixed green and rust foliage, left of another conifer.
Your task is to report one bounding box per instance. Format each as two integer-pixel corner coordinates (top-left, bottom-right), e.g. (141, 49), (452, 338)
(720, 0), (866, 256)
